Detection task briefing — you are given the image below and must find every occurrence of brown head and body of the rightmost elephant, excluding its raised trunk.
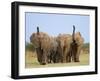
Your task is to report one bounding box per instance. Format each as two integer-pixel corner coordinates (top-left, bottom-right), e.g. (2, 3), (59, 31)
(71, 32), (84, 62)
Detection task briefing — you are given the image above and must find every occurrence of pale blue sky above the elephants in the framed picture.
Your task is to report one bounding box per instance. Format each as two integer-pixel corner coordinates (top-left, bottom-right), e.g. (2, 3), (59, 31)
(25, 12), (90, 43)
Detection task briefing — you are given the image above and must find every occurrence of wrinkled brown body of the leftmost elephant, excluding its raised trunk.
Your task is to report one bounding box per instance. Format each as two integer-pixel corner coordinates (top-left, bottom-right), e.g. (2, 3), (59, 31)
(30, 32), (51, 65)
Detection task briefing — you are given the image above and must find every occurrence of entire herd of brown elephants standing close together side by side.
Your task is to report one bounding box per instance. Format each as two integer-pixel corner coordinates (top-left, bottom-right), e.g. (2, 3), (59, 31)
(30, 26), (84, 65)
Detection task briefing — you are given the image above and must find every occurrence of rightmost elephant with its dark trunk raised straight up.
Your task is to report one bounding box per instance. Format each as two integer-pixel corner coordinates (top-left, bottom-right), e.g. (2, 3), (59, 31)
(67, 26), (84, 62)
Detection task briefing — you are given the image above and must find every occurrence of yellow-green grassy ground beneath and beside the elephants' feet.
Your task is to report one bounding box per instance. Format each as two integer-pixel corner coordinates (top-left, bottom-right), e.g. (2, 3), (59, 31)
(25, 51), (89, 68)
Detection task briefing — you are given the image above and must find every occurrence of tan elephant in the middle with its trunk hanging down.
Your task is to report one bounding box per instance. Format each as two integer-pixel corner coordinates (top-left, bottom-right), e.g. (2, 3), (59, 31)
(57, 34), (72, 63)
